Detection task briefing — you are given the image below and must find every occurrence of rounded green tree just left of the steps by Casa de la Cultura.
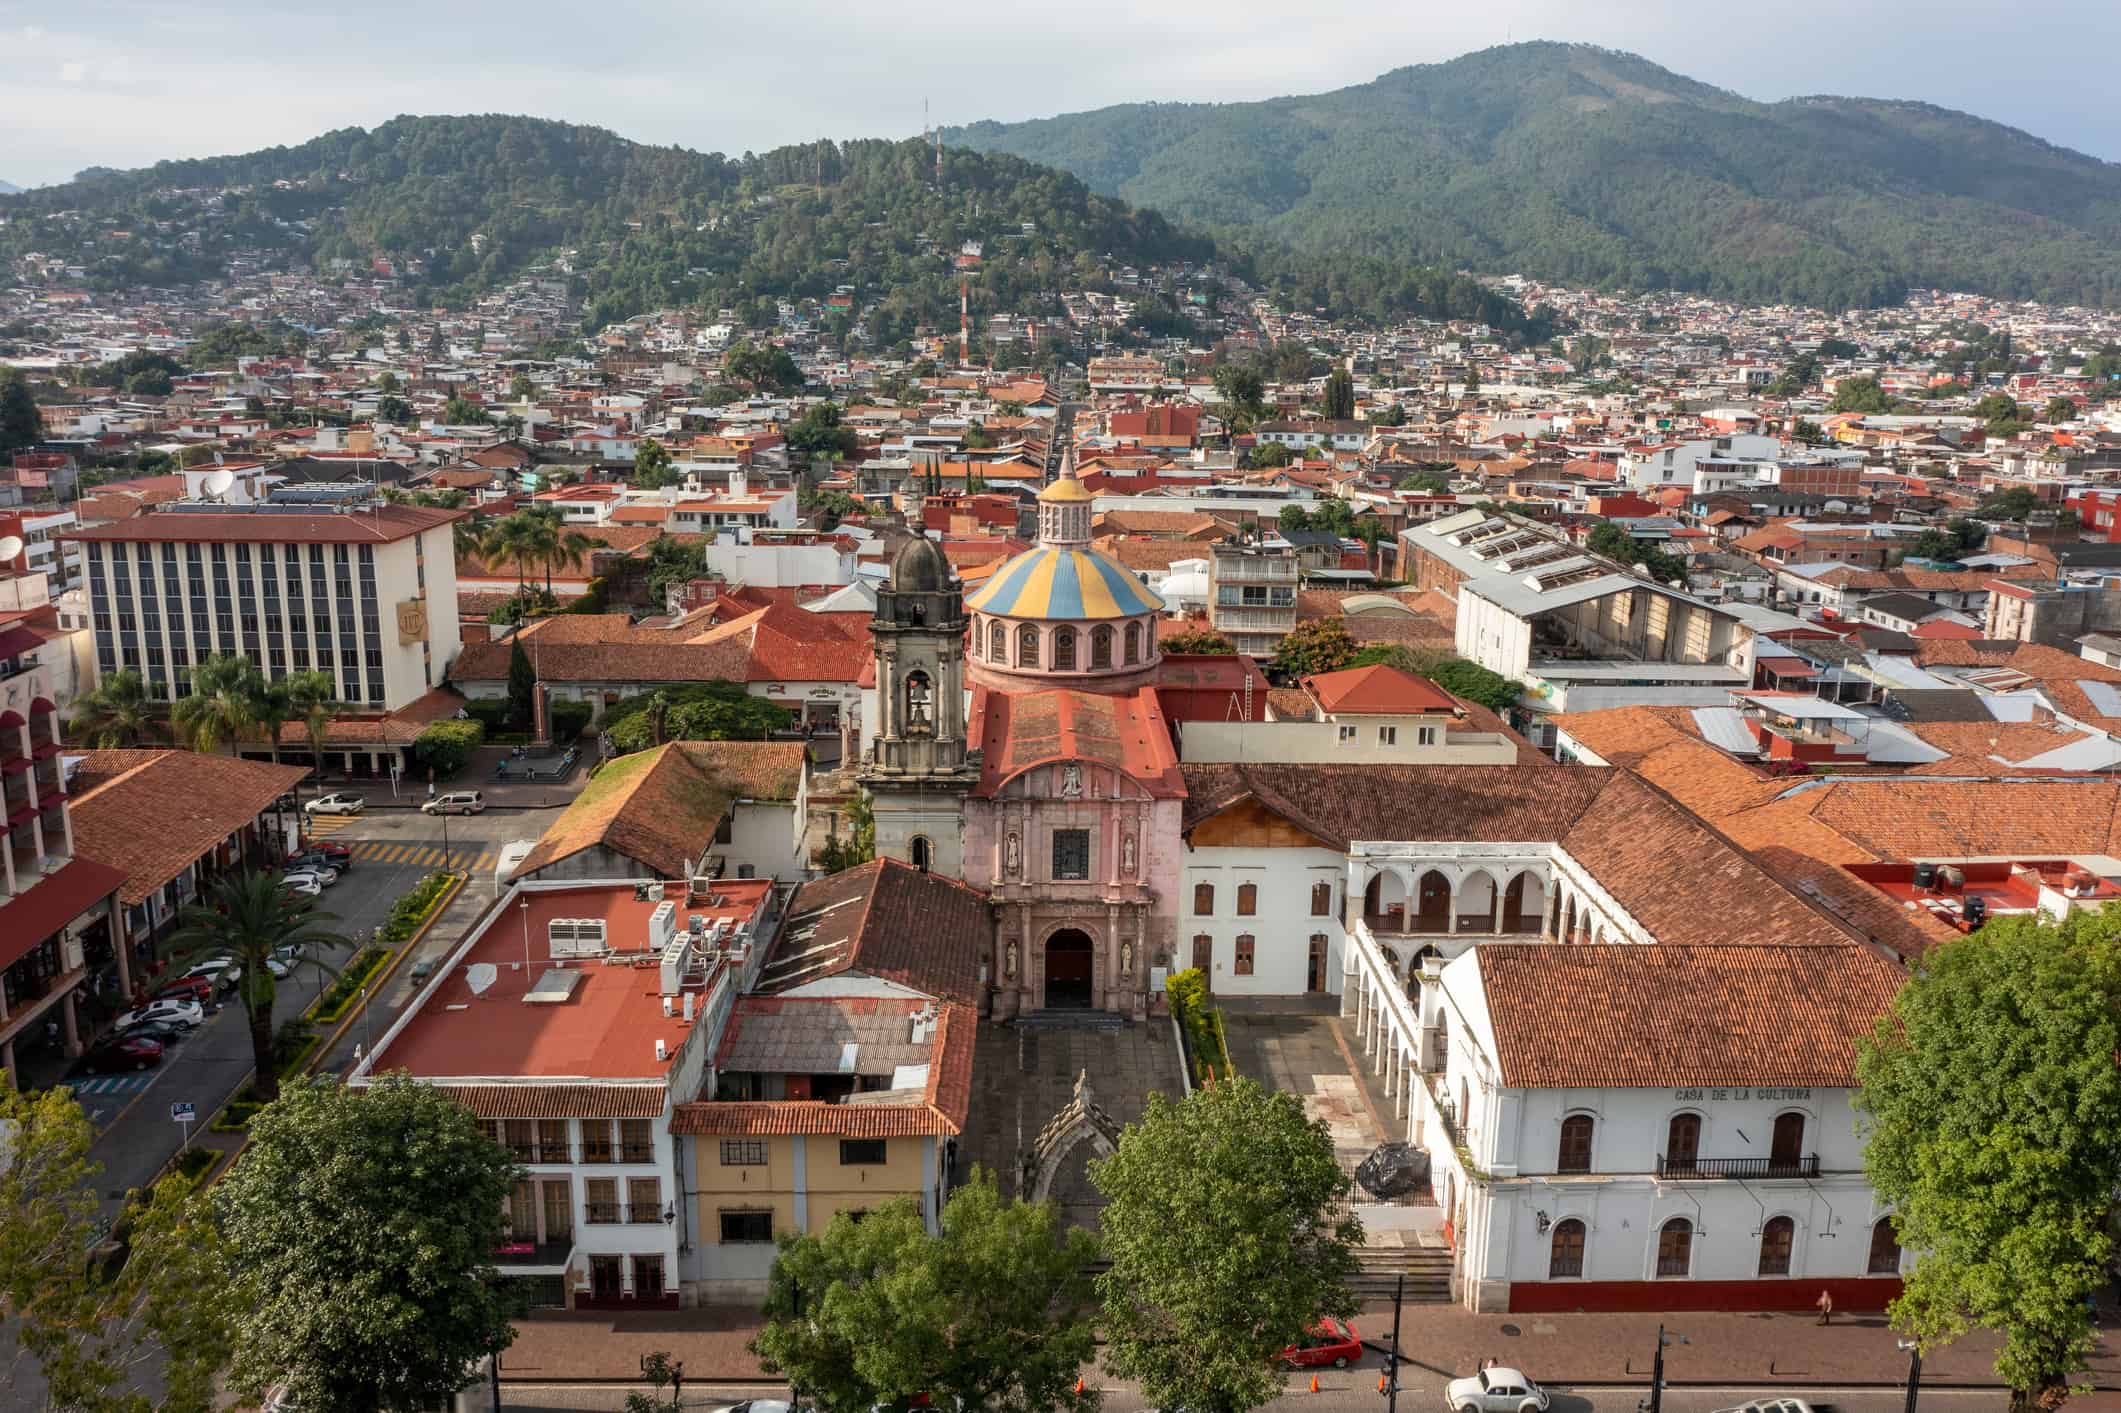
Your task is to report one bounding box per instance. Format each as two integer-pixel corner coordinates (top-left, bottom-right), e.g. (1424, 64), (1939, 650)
(1090, 1078), (1362, 1413)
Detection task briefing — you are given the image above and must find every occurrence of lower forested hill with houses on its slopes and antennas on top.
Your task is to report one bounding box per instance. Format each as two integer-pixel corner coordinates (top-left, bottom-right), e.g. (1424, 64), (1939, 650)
(0, 117), (1521, 344)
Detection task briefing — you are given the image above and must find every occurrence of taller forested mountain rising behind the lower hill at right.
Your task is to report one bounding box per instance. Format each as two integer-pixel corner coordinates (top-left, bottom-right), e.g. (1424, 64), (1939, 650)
(944, 42), (2121, 308)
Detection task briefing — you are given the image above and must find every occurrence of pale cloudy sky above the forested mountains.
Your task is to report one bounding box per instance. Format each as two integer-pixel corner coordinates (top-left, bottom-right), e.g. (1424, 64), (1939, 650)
(0, 0), (2121, 187)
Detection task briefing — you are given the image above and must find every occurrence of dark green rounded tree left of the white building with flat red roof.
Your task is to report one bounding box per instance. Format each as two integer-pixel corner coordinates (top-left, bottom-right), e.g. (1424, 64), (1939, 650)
(214, 1074), (522, 1411)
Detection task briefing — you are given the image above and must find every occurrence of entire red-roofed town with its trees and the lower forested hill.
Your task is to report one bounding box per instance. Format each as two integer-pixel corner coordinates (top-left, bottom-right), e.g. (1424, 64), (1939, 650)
(0, 27), (2121, 1413)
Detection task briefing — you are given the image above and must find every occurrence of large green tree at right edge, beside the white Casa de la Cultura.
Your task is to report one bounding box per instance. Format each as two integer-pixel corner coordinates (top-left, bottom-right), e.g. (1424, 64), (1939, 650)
(1856, 908), (2121, 1413)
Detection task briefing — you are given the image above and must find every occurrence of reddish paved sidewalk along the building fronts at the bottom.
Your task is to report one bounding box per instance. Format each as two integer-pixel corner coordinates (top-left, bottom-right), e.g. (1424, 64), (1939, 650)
(501, 1303), (2121, 1390)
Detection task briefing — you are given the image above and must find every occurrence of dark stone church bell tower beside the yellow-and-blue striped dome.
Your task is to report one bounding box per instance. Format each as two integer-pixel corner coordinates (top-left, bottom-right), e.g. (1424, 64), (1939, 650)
(859, 533), (980, 878)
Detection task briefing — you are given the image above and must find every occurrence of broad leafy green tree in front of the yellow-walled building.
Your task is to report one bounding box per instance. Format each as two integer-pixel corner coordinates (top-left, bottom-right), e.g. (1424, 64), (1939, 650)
(753, 1169), (1097, 1413)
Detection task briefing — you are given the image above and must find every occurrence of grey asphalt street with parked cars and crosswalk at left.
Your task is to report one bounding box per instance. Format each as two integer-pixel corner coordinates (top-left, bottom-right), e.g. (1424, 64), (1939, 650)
(68, 808), (558, 1216)
